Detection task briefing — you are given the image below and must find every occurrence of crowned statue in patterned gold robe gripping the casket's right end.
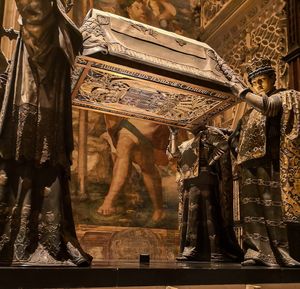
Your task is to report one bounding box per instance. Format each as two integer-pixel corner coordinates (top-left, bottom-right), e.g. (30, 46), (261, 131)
(231, 59), (300, 267)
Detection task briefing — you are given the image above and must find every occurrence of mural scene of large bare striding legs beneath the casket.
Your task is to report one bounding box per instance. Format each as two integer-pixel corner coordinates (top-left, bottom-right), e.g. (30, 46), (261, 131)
(72, 110), (182, 229)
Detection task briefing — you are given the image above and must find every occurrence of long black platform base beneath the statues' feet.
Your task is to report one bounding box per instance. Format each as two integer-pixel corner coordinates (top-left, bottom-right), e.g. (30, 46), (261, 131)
(0, 261), (300, 289)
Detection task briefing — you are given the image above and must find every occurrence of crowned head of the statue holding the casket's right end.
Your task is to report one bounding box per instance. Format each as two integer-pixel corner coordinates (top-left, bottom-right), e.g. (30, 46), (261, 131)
(247, 58), (276, 94)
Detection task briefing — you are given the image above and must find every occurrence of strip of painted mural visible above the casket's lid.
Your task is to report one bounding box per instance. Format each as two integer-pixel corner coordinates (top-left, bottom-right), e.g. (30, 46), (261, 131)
(73, 0), (199, 38)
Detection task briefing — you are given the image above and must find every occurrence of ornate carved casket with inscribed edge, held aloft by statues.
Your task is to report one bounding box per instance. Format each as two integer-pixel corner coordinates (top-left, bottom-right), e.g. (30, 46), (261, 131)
(73, 9), (236, 130)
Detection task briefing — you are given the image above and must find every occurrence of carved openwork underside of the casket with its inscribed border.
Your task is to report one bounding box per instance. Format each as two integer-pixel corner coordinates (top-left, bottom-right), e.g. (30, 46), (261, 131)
(73, 57), (236, 129)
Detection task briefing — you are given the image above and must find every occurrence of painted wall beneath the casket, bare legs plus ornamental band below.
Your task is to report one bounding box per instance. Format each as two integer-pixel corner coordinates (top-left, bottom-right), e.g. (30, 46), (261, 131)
(71, 109), (185, 260)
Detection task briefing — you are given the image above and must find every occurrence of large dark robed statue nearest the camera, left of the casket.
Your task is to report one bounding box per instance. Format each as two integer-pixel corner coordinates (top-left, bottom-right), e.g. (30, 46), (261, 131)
(0, 0), (92, 266)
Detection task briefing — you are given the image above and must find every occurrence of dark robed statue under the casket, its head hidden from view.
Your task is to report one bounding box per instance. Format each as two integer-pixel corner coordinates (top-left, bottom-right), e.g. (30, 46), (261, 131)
(169, 127), (243, 262)
